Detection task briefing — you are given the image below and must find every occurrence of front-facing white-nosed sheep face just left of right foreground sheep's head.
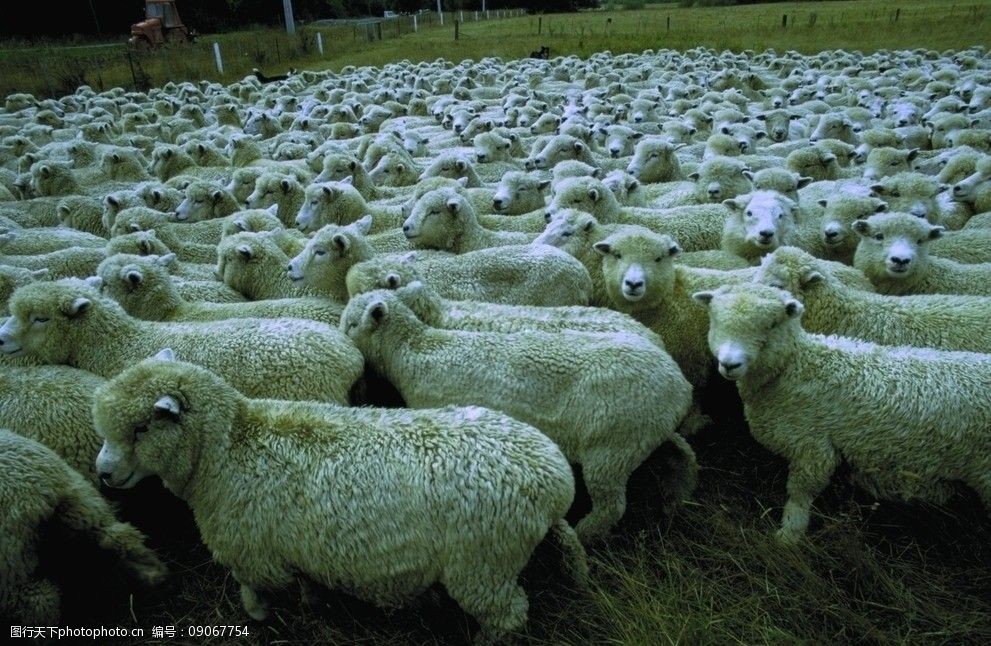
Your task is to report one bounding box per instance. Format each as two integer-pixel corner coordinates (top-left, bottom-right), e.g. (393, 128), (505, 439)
(594, 229), (681, 309)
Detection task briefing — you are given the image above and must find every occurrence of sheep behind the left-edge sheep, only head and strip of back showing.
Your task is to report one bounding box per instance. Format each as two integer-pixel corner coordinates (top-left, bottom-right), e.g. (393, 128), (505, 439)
(96, 254), (343, 327)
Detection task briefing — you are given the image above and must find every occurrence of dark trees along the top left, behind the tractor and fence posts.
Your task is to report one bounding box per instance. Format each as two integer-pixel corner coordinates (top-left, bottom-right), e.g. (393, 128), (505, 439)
(0, 0), (595, 39)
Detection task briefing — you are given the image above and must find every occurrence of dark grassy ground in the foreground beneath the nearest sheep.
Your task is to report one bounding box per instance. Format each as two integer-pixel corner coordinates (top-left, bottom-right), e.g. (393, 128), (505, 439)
(52, 383), (991, 644)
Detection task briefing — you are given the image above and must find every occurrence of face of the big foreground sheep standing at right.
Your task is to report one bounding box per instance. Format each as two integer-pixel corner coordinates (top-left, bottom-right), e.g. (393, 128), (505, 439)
(692, 284), (803, 381)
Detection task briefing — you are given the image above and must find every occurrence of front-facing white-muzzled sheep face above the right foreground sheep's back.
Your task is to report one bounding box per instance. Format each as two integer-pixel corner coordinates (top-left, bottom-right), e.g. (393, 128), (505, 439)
(853, 213), (943, 280)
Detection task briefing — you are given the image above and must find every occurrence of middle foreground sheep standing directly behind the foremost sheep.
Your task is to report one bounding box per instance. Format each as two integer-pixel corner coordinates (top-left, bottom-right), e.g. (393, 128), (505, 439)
(341, 290), (696, 542)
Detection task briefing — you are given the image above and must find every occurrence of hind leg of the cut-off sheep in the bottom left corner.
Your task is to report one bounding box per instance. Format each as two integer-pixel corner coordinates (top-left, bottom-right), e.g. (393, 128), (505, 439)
(56, 476), (168, 585)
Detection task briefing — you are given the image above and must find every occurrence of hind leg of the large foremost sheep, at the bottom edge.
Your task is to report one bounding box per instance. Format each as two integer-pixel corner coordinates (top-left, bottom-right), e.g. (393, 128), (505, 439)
(444, 563), (530, 644)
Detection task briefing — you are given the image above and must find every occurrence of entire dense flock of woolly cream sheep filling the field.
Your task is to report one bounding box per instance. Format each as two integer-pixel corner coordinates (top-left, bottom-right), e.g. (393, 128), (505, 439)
(0, 41), (991, 641)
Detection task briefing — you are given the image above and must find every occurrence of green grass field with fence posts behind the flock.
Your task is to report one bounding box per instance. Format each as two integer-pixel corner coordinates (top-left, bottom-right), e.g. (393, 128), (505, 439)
(0, 0), (991, 96)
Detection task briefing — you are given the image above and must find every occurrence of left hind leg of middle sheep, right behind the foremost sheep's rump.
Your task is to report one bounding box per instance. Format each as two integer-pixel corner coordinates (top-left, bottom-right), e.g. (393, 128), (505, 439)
(575, 450), (637, 545)
